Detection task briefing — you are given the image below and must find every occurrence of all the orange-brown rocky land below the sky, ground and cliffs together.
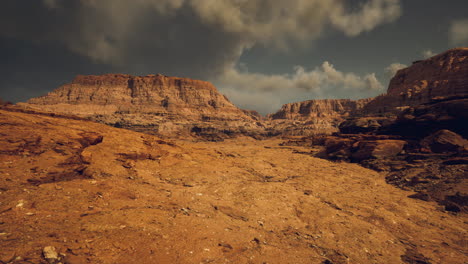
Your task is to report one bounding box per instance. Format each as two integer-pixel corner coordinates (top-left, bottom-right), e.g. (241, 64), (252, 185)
(0, 48), (468, 264)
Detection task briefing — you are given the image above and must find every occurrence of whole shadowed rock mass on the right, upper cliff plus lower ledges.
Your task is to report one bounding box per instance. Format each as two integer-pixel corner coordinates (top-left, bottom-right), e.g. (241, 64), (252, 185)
(284, 48), (468, 213)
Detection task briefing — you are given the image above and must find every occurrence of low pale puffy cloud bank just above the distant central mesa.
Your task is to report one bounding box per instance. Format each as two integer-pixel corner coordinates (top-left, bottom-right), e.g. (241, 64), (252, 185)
(213, 61), (384, 114)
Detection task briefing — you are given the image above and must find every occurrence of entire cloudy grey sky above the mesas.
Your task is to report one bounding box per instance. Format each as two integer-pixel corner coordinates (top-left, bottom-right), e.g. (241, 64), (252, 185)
(0, 0), (468, 114)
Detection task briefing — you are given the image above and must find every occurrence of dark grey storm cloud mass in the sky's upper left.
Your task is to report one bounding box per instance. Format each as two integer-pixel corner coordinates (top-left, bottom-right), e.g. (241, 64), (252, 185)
(0, 0), (247, 78)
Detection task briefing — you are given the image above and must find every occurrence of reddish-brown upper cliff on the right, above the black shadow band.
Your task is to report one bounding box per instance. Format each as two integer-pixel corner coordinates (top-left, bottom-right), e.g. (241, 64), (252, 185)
(364, 48), (468, 114)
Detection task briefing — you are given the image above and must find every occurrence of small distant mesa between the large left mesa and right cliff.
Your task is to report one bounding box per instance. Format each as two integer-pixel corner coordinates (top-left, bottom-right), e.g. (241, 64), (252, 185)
(267, 98), (372, 136)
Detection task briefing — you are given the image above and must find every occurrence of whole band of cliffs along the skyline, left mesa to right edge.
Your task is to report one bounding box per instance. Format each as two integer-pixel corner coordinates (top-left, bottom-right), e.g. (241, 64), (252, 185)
(22, 48), (468, 140)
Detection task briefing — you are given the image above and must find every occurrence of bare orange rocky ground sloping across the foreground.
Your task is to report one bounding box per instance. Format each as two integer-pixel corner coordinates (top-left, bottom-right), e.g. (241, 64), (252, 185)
(0, 107), (468, 264)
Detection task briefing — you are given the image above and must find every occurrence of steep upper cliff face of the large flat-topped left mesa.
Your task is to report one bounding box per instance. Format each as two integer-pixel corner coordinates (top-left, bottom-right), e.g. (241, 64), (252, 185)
(28, 74), (248, 119)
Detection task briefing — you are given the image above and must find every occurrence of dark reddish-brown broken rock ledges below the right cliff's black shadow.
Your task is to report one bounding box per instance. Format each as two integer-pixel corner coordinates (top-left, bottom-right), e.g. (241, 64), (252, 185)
(282, 130), (468, 213)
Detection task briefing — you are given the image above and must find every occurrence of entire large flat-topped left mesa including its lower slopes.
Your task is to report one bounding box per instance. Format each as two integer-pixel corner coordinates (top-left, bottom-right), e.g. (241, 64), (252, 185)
(23, 74), (266, 140)
